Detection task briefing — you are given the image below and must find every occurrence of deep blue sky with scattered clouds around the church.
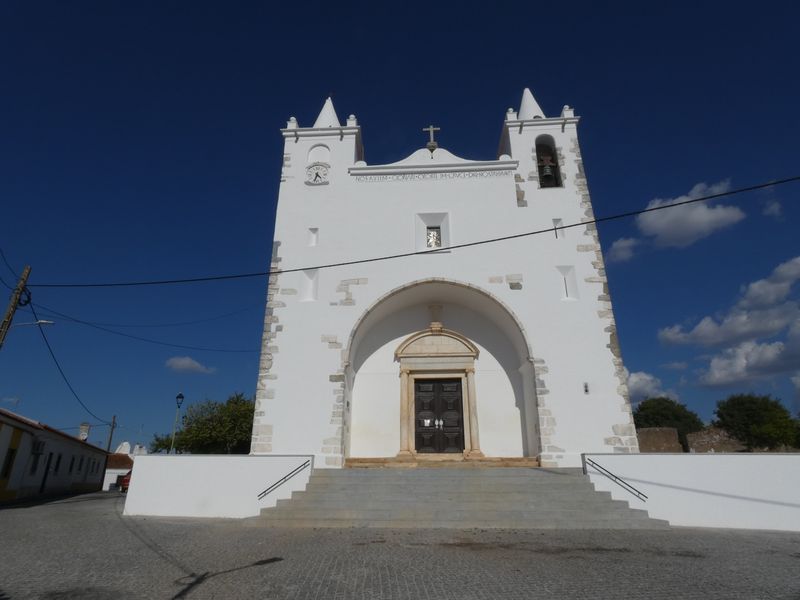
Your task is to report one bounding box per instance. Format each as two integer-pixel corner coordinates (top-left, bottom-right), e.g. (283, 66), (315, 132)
(0, 1), (800, 443)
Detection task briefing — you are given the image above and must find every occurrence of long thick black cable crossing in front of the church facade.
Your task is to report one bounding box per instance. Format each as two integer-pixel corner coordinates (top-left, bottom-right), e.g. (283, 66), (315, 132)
(23, 175), (800, 288)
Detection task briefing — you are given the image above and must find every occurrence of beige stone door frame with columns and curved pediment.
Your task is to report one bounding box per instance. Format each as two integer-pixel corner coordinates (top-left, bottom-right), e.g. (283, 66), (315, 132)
(395, 322), (483, 460)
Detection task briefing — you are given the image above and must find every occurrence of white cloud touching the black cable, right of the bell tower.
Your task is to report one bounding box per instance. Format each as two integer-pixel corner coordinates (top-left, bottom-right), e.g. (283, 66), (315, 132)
(636, 180), (745, 248)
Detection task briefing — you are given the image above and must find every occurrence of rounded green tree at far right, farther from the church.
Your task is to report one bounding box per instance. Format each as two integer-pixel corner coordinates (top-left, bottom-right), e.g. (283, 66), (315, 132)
(714, 394), (797, 450)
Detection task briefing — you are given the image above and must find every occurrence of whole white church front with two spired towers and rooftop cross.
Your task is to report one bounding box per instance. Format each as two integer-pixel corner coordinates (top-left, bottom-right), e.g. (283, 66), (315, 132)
(251, 89), (638, 468)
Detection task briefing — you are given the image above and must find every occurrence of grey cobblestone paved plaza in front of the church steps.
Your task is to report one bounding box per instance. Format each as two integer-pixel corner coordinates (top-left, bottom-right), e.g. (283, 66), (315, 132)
(0, 493), (800, 600)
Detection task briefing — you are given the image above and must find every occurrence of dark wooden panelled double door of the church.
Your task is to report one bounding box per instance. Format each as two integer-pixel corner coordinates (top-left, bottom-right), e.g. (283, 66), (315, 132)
(414, 379), (464, 454)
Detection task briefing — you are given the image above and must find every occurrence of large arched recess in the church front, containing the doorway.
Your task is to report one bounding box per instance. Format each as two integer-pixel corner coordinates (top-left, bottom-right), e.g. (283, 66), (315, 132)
(343, 279), (540, 458)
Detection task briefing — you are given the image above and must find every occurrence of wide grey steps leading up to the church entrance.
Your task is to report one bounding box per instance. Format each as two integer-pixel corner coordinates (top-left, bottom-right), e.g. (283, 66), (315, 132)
(261, 467), (668, 529)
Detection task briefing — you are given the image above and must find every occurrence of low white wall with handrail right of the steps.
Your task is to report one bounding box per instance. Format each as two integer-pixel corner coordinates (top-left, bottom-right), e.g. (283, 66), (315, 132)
(586, 454), (800, 531)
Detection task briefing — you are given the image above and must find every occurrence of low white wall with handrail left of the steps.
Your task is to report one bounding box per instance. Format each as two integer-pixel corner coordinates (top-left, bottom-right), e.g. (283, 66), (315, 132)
(124, 454), (314, 518)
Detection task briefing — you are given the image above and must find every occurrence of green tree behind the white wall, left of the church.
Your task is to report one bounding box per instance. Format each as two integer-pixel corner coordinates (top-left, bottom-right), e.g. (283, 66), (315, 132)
(150, 393), (255, 454)
